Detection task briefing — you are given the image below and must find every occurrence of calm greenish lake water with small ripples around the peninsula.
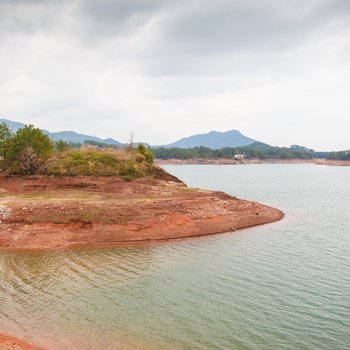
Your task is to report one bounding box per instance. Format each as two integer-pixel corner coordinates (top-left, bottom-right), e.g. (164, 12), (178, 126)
(0, 165), (350, 350)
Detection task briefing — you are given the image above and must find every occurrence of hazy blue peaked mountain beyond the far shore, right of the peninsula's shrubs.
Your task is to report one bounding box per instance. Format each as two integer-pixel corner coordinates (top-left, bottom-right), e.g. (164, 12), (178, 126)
(162, 130), (256, 149)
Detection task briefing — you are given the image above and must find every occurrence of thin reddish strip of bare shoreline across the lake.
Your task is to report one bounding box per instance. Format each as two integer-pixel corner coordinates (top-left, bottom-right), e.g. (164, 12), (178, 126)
(156, 158), (350, 166)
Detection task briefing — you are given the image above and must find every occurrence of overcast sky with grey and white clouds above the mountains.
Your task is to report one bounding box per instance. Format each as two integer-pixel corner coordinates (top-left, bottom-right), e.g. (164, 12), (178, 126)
(0, 0), (350, 150)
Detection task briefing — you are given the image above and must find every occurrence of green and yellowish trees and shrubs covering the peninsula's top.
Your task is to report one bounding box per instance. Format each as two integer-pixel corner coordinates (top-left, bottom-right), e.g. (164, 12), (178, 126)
(0, 123), (159, 180)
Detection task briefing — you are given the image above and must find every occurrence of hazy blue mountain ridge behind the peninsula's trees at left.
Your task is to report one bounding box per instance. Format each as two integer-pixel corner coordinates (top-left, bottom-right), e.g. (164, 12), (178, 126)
(0, 119), (122, 145)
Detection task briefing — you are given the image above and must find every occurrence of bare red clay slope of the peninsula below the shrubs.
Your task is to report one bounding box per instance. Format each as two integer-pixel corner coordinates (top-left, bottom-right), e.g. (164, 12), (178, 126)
(0, 176), (283, 250)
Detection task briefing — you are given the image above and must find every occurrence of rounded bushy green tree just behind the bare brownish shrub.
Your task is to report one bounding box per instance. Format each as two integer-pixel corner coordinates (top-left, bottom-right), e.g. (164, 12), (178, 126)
(5, 125), (53, 162)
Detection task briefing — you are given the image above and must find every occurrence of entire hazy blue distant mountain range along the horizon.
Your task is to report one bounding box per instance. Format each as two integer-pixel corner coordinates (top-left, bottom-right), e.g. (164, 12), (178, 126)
(0, 119), (256, 149)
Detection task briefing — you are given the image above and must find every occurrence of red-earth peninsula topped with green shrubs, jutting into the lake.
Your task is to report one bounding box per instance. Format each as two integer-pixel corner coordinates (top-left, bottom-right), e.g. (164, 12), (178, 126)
(0, 121), (283, 250)
